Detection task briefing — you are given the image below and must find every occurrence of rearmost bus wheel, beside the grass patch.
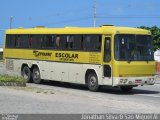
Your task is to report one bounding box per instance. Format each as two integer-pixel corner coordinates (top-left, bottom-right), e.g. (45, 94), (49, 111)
(21, 66), (32, 82)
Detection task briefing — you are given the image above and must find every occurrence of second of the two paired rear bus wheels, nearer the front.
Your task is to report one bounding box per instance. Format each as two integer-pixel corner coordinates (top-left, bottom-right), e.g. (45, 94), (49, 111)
(32, 67), (42, 84)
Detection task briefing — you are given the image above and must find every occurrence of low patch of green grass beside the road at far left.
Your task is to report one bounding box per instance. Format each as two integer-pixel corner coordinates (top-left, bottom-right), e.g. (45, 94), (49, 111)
(0, 75), (26, 82)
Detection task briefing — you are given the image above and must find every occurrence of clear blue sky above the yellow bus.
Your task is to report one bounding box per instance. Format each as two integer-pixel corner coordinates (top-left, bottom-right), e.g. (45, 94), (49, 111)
(0, 0), (160, 46)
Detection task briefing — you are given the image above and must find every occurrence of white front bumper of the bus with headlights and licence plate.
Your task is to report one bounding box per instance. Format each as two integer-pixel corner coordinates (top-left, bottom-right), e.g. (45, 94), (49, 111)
(113, 76), (155, 86)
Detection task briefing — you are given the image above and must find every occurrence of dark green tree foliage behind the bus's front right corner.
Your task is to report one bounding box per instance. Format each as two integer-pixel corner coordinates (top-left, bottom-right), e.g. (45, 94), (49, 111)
(139, 26), (160, 50)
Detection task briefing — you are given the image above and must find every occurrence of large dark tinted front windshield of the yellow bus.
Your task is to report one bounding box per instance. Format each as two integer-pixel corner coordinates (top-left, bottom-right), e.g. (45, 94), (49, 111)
(115, 34), (154, 61)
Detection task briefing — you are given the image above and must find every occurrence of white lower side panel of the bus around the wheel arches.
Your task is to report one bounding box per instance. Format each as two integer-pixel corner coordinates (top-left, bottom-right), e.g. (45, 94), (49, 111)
(6, 58), (105, 85)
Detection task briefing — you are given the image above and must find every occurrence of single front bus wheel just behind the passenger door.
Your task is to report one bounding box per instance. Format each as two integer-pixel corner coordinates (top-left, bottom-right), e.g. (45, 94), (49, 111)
(87, 73), (99, 92)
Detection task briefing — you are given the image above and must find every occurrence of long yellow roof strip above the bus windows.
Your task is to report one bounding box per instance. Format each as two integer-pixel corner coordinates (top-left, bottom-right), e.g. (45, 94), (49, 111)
(6, 26), (151, 35)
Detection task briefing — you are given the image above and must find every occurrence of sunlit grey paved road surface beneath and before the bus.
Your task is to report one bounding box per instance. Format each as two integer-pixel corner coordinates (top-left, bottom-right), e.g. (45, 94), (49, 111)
(0, 82), (160, 113)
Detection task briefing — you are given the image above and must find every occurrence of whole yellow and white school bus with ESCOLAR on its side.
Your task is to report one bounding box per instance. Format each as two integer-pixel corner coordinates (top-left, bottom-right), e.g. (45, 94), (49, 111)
(4, 25), (155, 91)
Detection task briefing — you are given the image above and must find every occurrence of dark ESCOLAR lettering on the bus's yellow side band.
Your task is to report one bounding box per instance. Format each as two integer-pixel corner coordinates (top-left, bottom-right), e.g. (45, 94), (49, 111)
(55, 53), (78, 61)
